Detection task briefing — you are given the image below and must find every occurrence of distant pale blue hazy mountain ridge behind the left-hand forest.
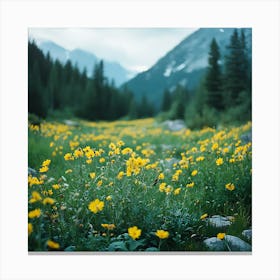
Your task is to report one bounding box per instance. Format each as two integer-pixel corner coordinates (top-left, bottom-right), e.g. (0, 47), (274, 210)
(38, 41), (136, 87)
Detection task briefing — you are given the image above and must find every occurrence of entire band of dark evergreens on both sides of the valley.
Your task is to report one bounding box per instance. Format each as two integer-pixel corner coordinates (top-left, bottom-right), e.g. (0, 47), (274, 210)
(28, 29), (252, 128)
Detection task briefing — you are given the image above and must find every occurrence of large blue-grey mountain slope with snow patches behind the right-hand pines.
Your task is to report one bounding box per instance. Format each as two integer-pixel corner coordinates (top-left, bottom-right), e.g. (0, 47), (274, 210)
(125, 28), (252, 106)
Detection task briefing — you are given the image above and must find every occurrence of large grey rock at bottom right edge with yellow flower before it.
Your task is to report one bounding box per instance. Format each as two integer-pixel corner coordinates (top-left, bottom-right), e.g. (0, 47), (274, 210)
(203, 235), (252, 251)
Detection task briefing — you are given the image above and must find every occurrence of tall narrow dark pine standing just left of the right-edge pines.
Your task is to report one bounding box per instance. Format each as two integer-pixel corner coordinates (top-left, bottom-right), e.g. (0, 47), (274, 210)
(205, 38), (224, 111)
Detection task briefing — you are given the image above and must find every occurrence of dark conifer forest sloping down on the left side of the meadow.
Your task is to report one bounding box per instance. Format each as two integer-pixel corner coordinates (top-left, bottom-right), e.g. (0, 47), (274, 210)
(28, 41), (154, 120)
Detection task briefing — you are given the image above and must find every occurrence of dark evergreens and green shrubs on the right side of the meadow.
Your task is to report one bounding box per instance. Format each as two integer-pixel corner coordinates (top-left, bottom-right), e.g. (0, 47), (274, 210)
(161, 29), (252, 128)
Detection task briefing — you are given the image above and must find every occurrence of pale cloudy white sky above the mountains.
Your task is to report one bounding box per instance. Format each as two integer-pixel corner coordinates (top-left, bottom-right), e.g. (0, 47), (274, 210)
(29, 28), (197, 71)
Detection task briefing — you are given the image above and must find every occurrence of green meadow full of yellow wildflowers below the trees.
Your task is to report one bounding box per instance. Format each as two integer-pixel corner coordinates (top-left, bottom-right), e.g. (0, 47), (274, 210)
(28, 119), (252, 251)
